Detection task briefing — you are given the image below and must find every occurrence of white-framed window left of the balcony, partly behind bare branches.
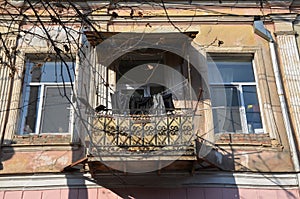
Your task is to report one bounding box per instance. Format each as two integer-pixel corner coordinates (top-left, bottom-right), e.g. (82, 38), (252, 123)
(20, 56), (74, 134)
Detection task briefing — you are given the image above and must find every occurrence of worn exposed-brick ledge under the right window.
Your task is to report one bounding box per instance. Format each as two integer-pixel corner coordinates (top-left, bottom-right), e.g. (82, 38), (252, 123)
(215, 134), (273, 147)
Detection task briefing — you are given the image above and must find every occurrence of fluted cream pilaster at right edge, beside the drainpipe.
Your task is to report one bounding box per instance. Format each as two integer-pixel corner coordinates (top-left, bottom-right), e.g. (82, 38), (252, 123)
(275, 15), (300, 150)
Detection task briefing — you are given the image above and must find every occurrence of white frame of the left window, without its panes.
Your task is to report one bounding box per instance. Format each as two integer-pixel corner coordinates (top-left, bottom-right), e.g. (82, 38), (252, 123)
(18, 56), (76, 135)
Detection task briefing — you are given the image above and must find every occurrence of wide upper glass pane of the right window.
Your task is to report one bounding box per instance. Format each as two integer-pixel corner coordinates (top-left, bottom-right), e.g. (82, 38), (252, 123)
(208, 61), (255, 83)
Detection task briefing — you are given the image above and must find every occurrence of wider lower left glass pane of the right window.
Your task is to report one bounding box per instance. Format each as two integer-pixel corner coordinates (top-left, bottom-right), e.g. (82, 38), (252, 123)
(211, 86), (242, 133)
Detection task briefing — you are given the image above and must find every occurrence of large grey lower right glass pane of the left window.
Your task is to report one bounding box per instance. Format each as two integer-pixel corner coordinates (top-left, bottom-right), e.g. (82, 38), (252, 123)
(41, 86), (71, 133)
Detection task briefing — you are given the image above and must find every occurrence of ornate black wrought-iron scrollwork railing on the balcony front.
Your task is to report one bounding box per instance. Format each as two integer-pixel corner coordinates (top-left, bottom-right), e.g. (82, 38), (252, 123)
(90, 111), (194, 155)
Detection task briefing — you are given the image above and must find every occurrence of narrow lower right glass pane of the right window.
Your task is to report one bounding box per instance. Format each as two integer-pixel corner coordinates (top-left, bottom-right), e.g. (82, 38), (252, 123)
(243, 86), (262, 133)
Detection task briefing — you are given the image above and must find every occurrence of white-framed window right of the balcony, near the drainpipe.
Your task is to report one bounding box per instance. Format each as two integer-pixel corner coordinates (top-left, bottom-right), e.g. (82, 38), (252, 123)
(208, 56), (263, 133)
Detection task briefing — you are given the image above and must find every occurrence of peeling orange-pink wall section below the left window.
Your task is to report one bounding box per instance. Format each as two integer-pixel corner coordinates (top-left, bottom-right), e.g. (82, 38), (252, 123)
(0, 146), (84, 174)
